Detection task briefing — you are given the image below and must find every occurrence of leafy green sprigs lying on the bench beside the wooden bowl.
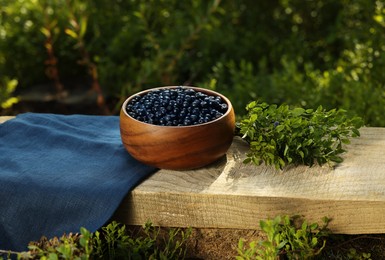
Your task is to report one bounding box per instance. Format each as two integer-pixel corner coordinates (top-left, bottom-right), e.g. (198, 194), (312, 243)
(237, 101), (363, 169)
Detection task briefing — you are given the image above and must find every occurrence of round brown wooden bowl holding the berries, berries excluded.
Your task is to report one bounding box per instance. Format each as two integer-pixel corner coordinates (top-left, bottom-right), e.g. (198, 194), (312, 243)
(120, 86), (235, 170)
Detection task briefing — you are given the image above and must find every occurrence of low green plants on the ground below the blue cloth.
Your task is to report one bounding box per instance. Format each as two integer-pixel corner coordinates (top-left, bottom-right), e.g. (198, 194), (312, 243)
(10, 221), (192, 260)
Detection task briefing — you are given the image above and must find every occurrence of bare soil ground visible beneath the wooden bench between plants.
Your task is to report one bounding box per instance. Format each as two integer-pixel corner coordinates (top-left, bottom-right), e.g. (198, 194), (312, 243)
(130, 226), (385, 260)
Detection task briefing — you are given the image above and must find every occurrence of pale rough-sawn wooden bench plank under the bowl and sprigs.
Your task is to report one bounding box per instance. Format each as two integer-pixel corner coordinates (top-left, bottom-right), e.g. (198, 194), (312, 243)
(0, 117), (385, 234)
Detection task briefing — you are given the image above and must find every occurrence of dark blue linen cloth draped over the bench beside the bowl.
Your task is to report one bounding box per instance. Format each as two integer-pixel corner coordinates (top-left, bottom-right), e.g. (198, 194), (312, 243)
(0, 113), (156, 251)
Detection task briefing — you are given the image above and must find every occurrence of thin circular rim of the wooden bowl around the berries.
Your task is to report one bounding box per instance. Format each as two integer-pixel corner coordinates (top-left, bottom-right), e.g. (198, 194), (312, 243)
(121, 85), (233, 128)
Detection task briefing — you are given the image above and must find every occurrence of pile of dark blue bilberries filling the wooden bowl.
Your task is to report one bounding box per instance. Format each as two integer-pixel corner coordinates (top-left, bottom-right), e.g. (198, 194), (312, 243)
(126, 87), (228, 126)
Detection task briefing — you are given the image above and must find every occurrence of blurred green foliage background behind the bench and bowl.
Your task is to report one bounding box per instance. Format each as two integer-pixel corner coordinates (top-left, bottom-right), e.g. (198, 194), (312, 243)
(0, 0), (385, 126)
